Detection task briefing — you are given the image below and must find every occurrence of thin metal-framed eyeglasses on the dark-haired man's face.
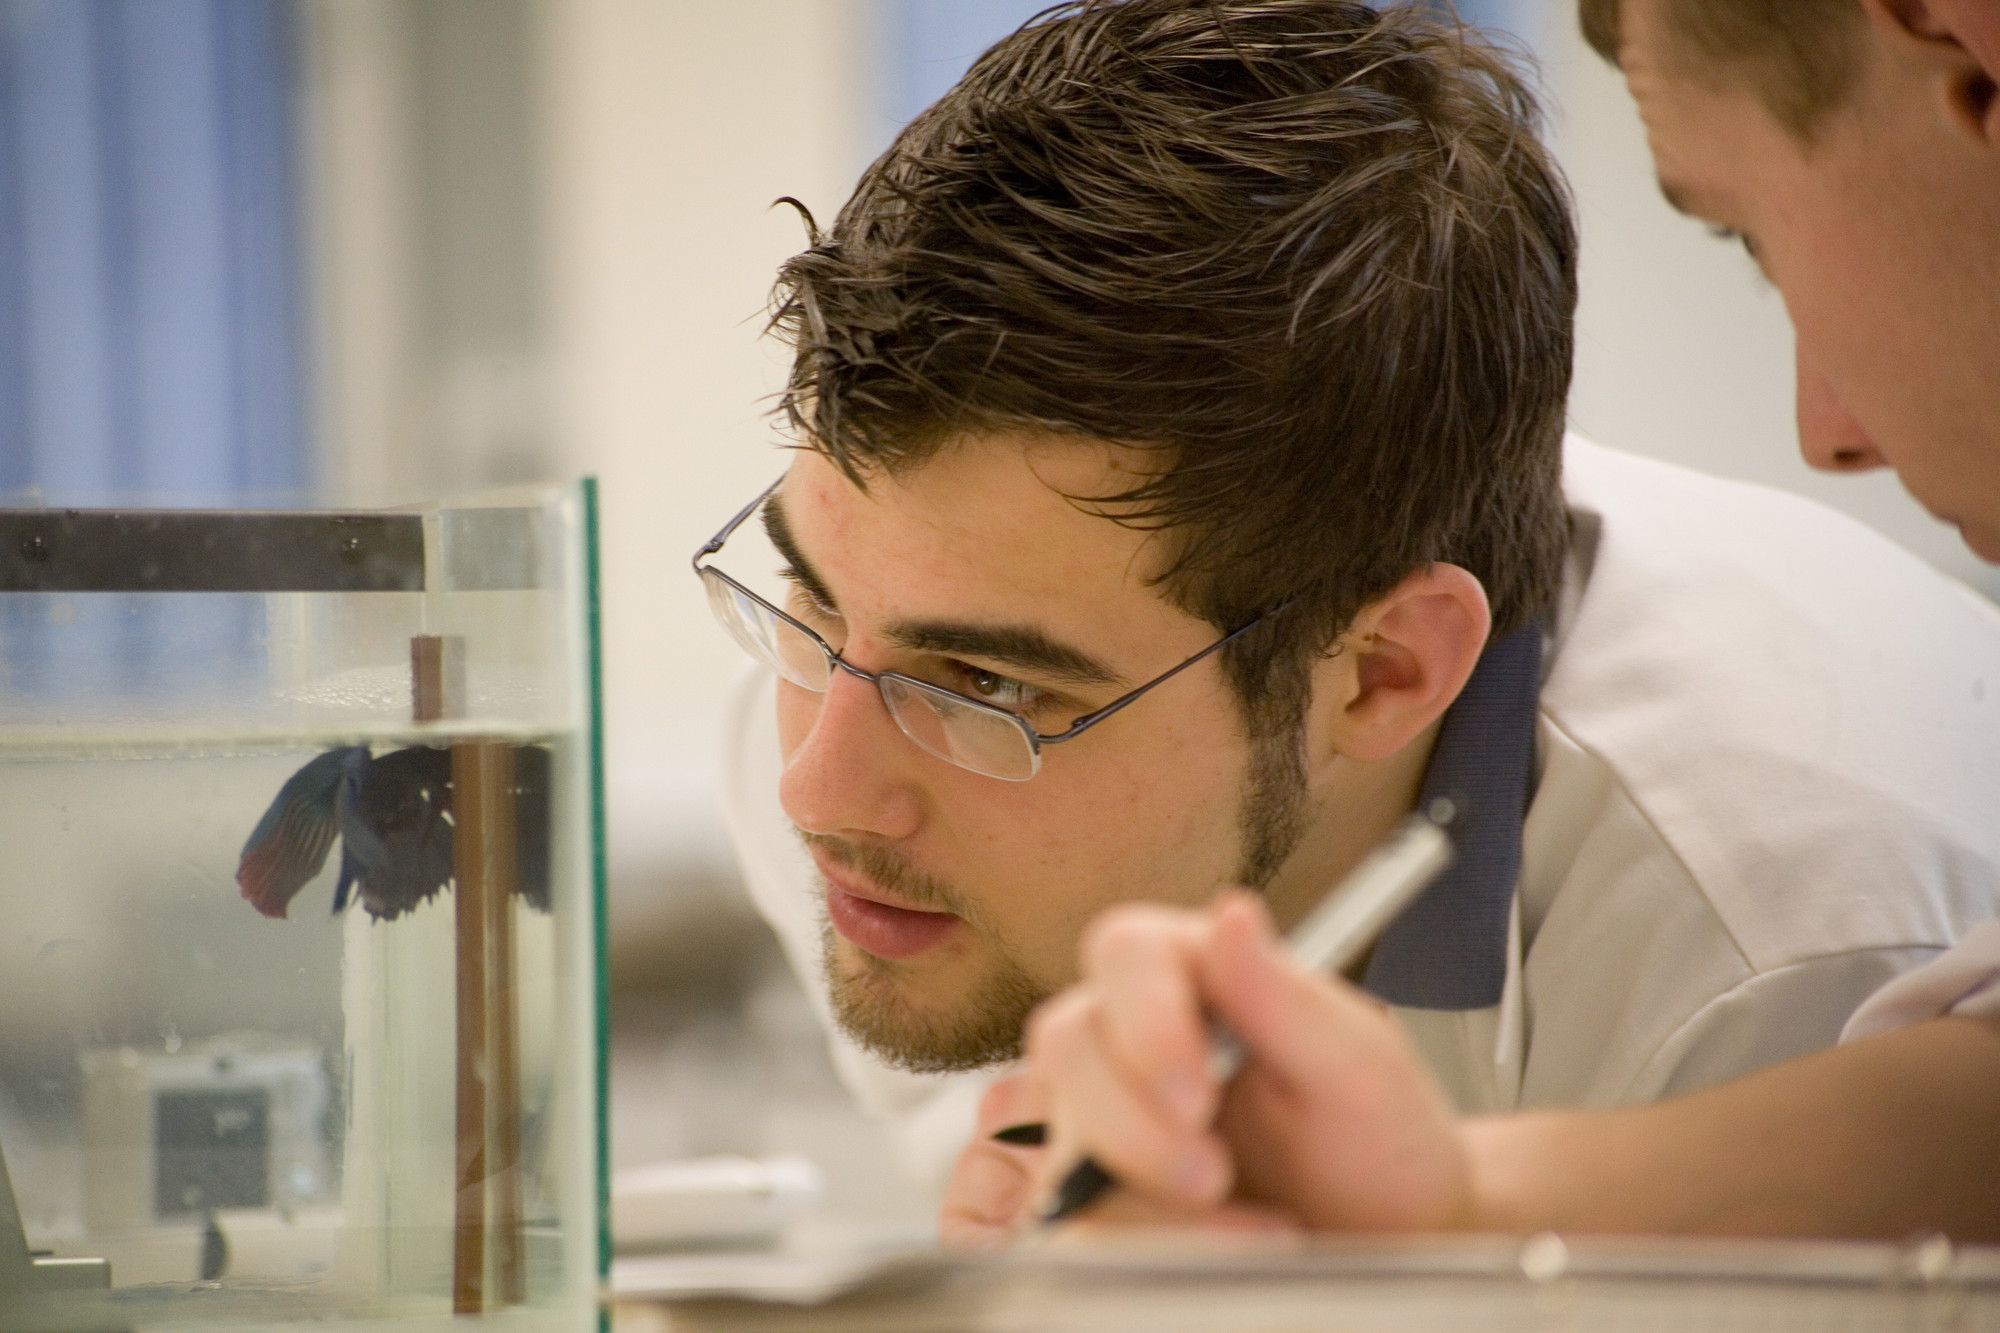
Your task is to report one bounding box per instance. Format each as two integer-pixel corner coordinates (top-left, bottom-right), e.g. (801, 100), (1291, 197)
(694, 482), (1290, 783)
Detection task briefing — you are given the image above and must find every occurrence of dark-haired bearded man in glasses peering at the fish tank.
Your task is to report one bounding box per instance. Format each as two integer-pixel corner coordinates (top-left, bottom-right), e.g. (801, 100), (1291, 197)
(696, 0), (2000, 1192)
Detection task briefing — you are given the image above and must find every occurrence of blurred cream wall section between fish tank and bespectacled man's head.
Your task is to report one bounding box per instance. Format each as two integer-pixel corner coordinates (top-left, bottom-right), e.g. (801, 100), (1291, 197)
(544, 0), (870, 933)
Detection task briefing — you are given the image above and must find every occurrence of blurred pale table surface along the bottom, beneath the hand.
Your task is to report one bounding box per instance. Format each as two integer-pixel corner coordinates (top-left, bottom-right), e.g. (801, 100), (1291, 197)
(614, 1233), (2000, 1333)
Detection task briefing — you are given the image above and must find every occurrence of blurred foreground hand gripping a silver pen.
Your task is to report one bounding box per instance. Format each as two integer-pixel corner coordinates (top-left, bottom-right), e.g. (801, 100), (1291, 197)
(942, 792), (1468, 1245)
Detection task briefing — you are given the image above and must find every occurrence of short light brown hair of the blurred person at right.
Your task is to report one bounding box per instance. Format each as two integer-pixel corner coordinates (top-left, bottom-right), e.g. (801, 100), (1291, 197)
(1576, 0), (1862, 138)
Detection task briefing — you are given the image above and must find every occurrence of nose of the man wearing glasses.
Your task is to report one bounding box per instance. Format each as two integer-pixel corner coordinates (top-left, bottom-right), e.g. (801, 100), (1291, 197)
(778, 671), (924, 839)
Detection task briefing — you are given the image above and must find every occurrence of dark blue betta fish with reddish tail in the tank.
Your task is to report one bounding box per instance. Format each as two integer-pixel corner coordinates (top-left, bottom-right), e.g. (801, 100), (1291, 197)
(236, 745), (550, 921)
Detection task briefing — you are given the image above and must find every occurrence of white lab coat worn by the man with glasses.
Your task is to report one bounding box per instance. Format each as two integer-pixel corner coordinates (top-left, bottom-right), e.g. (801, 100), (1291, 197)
(726, 436), (2000, 1181)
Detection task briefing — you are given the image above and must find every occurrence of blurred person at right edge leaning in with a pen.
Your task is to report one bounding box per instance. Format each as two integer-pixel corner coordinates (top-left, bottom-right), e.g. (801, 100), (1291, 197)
(946, 0), (2000, 1241)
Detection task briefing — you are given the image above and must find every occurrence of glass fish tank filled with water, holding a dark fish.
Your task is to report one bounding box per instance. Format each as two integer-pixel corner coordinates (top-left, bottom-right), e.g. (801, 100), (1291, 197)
(0, 482), (606, 1333)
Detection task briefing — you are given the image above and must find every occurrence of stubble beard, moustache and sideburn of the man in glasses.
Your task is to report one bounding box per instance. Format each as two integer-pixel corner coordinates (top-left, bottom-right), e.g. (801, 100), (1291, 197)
(804, 731), (1306, 1073)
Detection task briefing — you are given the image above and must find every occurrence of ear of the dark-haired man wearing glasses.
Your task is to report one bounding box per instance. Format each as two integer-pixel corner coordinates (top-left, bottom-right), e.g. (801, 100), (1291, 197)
(1314, 564), (1492, 761)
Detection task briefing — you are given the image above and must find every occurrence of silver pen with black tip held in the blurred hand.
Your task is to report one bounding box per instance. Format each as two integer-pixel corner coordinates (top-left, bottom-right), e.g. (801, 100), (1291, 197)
(1040, 797), (1458, 1223)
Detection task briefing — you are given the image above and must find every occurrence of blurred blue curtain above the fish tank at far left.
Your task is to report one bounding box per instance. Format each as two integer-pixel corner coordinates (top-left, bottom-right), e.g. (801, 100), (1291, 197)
(0, 0), (310, 504)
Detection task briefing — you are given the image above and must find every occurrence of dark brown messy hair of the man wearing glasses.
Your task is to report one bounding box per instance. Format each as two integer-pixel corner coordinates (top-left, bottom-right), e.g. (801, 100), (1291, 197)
(774, 0), (1576, 737)
